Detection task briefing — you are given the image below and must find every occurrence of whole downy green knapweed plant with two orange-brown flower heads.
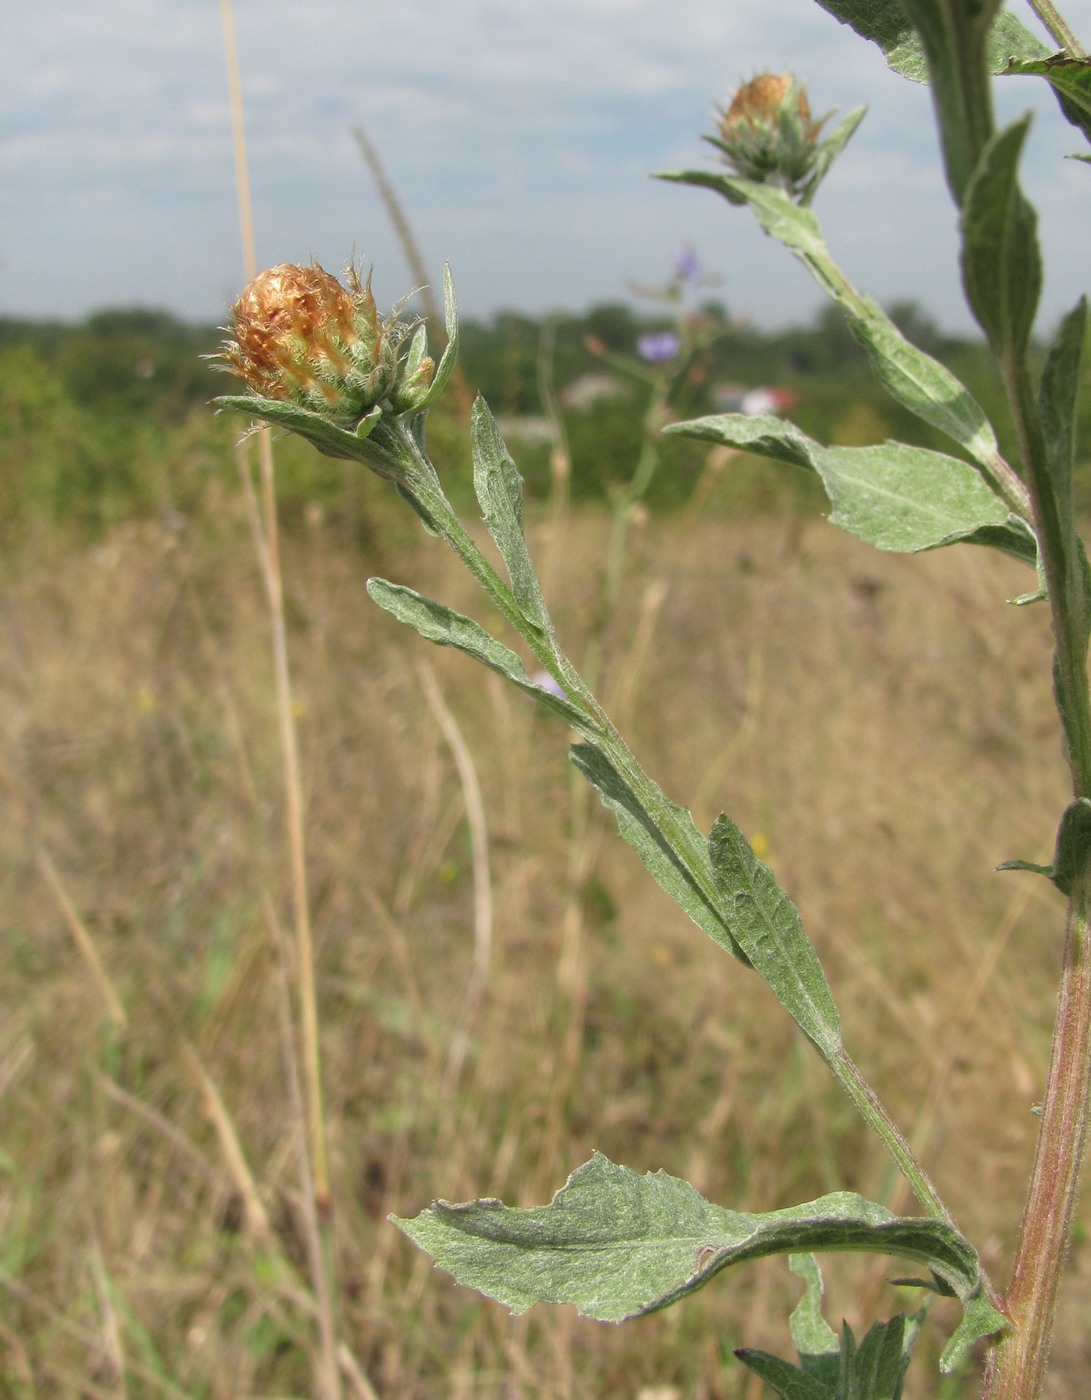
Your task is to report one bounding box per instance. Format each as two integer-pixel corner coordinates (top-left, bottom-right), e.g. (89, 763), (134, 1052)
(220, 0), (1091, 1400)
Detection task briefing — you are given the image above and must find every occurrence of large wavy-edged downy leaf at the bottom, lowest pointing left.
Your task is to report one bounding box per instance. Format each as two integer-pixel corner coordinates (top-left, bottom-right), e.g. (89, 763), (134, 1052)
(391, 1154), (999, 1330)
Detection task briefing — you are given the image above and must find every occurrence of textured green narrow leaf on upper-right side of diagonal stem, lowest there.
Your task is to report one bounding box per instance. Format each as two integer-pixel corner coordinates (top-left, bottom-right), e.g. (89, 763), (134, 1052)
(709, 816), (840, 1060)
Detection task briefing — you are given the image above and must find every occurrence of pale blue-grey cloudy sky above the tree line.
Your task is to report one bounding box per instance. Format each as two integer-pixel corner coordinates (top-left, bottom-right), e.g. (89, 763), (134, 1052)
(0, 0), (1091, 332)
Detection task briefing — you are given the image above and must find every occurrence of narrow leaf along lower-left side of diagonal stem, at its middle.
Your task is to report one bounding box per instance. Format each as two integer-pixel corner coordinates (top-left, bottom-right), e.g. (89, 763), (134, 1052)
(569, 743), (749, 966)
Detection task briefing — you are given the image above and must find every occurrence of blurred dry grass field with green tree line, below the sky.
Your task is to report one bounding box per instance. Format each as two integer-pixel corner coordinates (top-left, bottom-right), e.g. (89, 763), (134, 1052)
(0, 307), (1091, 1400)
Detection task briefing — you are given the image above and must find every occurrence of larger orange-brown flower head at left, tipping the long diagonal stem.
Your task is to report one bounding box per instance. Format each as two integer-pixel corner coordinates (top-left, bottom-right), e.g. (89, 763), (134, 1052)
(223, 263), (434, 426)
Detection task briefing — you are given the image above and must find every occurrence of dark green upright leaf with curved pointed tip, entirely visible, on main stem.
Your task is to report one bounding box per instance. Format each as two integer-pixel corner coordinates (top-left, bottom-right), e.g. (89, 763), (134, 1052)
(962, 118), (1042, 361)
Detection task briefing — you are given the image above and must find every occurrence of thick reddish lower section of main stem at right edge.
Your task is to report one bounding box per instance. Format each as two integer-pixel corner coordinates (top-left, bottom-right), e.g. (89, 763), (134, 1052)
(985, 888), (1091, 1400)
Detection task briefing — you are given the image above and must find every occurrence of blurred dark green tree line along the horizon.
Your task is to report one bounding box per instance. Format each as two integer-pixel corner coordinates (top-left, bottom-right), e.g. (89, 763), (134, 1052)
(0, 301), (1091, 526)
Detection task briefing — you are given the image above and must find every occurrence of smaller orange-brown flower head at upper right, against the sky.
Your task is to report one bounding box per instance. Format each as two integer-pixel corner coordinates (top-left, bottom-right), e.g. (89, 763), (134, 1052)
(711, 73), (826, 196)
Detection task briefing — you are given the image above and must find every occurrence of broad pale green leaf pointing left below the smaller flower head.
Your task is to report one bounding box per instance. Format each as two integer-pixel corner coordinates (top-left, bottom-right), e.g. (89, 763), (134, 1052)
(665, 413), (1025, 553)
